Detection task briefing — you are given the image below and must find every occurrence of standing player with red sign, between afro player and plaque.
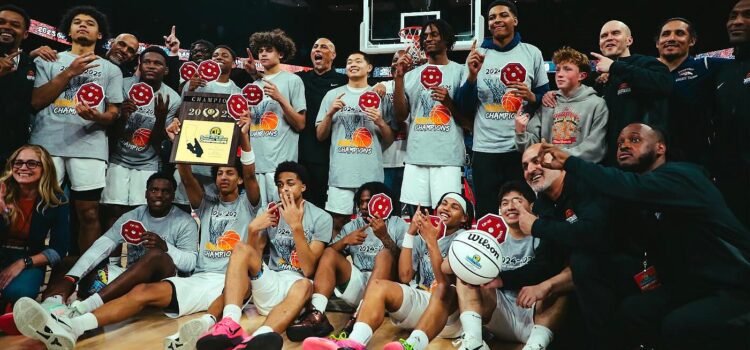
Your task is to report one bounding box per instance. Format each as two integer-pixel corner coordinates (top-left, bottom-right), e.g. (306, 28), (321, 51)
(102, 46), (180, 227)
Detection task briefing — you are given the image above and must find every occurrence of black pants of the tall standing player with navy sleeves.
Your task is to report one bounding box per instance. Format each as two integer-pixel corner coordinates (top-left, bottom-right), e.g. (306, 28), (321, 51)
(472, 151), (523, 218)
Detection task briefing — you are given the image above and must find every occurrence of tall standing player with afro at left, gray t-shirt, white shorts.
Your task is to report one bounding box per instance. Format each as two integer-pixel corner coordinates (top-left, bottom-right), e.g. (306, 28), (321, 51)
(30, 6), (123, 252)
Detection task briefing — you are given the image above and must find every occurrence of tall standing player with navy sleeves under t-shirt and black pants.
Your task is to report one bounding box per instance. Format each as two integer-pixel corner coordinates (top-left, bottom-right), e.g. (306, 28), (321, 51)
(456, 0), (549, 217)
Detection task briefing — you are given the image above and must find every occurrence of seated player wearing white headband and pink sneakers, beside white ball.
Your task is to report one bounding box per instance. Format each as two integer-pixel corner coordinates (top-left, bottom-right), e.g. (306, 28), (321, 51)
(302, 192), (474, 350)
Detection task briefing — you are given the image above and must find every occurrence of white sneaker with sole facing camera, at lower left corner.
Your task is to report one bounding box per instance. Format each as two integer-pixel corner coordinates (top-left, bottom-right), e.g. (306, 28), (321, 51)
(13, 297), (78, 350)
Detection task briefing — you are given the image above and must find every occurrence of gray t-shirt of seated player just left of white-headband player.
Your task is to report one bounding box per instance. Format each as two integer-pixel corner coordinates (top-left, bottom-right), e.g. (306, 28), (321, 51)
(332, 216), (409, 271)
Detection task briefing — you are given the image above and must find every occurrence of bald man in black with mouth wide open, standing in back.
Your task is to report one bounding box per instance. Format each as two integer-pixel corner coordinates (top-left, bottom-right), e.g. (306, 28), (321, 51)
(297, 38), (348, 208)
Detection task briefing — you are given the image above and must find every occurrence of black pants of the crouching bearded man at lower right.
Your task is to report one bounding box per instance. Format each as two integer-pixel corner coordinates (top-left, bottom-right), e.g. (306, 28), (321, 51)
(615, 287), (750, 350)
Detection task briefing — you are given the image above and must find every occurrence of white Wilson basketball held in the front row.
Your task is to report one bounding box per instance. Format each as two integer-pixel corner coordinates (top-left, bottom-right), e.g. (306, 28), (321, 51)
(448, 230), (502, 285)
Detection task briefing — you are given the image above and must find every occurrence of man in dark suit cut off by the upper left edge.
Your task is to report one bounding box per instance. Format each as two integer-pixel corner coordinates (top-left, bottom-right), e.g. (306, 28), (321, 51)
(0, 5), (36, 165)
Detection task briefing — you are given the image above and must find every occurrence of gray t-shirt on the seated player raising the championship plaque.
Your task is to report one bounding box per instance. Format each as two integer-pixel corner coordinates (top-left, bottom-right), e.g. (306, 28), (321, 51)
(195, 193), (257, 273)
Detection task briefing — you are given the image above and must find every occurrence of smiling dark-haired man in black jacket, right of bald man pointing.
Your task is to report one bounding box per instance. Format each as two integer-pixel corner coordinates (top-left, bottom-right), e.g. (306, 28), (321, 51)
(656, 17), (727, 166)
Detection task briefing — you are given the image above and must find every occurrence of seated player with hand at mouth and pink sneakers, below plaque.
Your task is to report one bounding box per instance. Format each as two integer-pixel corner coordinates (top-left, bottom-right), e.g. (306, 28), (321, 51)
(197, 162), (333, 349)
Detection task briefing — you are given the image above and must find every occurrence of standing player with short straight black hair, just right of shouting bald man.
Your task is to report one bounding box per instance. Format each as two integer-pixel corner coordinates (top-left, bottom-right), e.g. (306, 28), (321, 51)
(315, 51), (393, 235)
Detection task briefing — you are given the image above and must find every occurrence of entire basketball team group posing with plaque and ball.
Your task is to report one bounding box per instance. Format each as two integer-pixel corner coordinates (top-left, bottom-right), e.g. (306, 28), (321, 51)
(0, 0), (750, 350)
